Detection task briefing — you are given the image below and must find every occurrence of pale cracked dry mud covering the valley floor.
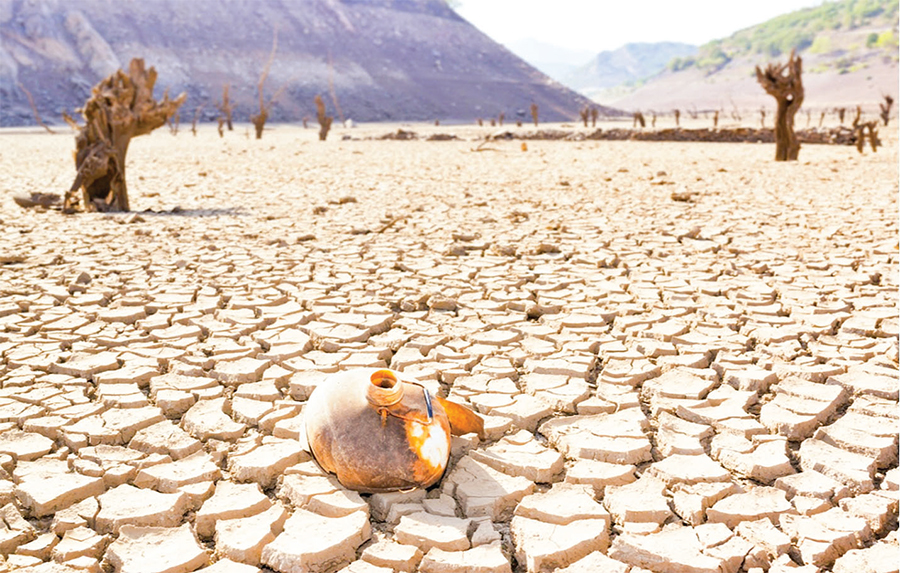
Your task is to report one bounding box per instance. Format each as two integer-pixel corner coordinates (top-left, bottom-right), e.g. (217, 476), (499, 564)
(0, 126), (900, 573)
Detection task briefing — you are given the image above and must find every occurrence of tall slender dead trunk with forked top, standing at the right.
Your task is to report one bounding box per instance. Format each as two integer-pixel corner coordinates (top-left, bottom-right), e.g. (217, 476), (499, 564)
(756, 50), (804, 161)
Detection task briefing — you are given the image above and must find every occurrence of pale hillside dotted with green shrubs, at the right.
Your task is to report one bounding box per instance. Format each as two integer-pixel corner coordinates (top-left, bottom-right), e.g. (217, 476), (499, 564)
(600, 0), (898, 113)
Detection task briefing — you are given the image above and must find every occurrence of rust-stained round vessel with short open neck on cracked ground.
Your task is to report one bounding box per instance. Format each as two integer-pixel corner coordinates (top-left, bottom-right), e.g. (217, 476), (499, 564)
(303, 368), (483, 492)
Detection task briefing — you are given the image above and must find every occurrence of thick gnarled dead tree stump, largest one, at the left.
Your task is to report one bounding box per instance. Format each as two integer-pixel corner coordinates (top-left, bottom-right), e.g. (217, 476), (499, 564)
(63, 58), (187, 213)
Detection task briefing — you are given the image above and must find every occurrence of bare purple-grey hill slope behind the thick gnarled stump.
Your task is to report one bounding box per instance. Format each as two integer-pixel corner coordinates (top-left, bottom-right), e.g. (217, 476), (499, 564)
(0, 0), (604, 125)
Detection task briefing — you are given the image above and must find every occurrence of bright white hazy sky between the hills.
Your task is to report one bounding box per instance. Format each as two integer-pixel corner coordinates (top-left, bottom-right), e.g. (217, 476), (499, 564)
(456, 0), (822, 52)
